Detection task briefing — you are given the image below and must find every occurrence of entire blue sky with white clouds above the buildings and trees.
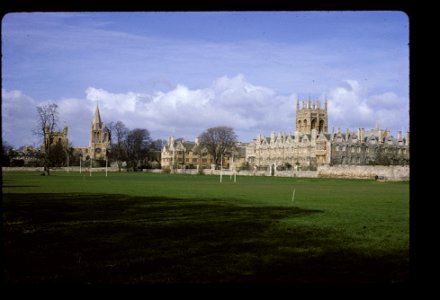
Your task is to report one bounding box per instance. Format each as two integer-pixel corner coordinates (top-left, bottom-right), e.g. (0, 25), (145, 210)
(1, 11), (409, 147)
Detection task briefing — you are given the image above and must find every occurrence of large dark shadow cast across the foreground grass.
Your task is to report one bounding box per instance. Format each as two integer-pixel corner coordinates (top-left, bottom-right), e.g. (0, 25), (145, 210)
(3, 194), (408, 283)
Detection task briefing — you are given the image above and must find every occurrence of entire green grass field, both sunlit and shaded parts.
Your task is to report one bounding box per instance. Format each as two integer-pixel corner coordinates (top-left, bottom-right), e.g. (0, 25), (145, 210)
(2, 172), (409, 284)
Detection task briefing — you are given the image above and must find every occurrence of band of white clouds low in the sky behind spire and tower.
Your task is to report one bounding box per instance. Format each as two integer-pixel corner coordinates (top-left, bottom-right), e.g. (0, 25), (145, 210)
(2, 74), (409, 146)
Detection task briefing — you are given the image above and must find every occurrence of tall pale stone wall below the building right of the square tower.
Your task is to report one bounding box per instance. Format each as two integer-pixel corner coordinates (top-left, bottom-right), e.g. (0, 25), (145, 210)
(318, 165), (409, 181)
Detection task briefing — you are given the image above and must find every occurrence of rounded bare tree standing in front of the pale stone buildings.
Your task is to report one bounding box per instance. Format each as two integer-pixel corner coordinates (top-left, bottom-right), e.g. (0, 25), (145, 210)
(199, 126), (237, 166)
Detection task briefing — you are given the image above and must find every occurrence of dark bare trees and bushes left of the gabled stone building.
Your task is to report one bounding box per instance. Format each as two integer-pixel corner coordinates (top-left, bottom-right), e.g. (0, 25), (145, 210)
(2, 104), (163, 175)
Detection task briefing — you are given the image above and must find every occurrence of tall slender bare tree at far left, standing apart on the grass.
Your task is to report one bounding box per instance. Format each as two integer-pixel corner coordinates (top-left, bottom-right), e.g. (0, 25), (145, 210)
(34, 103), (58, 175)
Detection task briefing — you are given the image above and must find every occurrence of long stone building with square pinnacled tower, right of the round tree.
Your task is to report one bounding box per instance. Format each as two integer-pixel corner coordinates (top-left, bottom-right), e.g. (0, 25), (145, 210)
(246, 99), (409, 170)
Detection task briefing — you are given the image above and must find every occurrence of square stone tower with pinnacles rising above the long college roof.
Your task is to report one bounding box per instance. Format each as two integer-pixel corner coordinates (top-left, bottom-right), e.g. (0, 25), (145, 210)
(296, 97), (328, 134)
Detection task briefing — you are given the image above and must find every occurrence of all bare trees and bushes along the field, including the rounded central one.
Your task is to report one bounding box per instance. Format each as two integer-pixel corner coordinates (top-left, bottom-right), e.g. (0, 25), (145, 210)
(2, 104), (241, 175)
